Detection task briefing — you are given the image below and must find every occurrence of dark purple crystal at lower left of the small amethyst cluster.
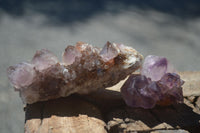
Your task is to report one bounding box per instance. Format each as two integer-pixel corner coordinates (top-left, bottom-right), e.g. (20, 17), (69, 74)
(121, 75), (158, 108)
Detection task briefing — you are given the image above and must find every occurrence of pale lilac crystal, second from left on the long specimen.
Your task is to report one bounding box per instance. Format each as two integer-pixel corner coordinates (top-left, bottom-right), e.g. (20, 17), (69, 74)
(31, 49), (58, 71)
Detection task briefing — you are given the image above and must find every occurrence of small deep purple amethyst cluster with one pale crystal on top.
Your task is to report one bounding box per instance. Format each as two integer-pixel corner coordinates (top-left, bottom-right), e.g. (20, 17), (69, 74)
(121, 55), (184, 109)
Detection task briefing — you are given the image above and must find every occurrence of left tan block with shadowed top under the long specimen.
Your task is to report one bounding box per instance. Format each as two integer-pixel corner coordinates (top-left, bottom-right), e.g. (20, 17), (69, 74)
(25, 96), (106, 133)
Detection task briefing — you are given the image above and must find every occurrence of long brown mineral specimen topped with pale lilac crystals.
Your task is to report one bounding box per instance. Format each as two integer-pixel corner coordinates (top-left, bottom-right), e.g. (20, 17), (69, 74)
(7, 42), (143, 104)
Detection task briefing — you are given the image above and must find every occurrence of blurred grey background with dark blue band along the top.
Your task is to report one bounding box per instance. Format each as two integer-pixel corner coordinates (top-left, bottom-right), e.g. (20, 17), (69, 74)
(0, 0), (200, 133)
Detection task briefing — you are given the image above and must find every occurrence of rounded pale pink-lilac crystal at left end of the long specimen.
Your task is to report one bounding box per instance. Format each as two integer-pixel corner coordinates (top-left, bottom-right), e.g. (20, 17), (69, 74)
(7, 62), (36, 90)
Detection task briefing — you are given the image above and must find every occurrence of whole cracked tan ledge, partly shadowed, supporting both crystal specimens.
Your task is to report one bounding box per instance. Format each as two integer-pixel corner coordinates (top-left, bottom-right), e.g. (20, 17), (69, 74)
(25, 72), (200, 133)
